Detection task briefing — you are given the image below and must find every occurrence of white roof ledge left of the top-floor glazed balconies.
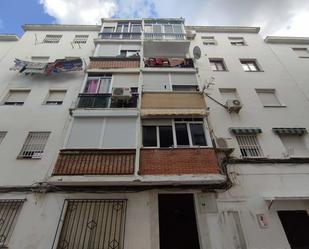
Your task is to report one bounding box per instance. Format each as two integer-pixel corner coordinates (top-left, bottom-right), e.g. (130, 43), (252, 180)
(22, 24), (101, 31)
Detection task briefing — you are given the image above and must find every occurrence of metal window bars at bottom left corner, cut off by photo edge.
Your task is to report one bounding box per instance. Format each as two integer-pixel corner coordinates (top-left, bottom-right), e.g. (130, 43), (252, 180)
(0, 200), (24, 248)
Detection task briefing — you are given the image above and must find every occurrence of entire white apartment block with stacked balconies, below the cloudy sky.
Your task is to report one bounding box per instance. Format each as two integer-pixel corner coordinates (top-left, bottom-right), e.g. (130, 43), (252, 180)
(0, 18), (309, 249)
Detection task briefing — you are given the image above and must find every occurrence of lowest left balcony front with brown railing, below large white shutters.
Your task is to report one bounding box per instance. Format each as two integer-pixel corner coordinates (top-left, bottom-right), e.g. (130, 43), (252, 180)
(53, 149), (135, 176)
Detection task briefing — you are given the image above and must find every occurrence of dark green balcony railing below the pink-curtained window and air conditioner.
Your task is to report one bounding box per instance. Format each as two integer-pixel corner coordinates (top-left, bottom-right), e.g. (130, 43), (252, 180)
(77, 93), (138, 108)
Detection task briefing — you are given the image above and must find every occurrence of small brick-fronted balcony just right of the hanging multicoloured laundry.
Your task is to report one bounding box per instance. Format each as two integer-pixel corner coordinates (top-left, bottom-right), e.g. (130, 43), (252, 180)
(89, 56), (140, 69)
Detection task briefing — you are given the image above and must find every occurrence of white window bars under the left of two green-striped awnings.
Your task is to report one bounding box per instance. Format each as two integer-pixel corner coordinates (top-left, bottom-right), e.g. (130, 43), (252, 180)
(236, 135), (263, 158)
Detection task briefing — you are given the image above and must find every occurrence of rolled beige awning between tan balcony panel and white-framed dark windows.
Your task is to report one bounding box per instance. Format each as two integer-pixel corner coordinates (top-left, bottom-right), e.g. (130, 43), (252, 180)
(141, 109), (207, 117)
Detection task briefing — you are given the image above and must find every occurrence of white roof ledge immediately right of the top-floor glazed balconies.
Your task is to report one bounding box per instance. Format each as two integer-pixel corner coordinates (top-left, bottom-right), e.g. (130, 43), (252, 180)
(186, 26), (260, 33)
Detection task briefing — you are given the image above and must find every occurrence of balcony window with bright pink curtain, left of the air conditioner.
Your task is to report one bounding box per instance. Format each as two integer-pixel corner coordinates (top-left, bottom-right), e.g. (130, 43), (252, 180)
(84, 75), (112, 93)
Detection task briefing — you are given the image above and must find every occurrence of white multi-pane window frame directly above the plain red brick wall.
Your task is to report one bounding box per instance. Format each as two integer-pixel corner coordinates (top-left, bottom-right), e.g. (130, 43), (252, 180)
(142, 118), (207, 149)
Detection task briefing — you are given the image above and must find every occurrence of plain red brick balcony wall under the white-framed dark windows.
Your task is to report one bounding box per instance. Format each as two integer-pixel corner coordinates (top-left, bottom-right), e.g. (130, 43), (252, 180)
(140, 148), (220, 175)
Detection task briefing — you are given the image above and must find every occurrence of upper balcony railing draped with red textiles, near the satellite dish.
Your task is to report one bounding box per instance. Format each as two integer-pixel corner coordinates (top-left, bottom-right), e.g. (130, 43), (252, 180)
(144, 58), (194, 68)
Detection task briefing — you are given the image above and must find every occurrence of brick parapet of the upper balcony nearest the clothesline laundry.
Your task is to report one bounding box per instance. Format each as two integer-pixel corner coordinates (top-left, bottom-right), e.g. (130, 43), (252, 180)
(89, 59), (140, 69)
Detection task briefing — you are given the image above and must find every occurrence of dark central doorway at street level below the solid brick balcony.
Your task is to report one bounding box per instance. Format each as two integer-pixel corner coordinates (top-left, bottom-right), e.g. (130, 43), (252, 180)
(159, 194), (200, 249)
